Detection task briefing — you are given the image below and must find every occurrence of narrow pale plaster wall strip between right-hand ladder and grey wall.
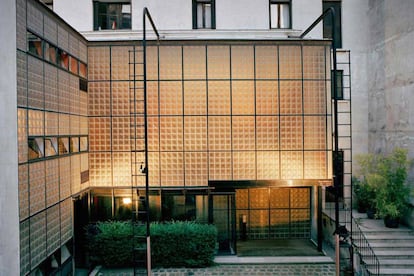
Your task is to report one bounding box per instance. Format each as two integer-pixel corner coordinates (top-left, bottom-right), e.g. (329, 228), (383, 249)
(342, 0), (372, 160)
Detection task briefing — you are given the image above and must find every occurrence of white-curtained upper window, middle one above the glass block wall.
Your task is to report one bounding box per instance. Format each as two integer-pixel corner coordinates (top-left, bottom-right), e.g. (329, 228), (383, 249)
(193, 0), (216, 29)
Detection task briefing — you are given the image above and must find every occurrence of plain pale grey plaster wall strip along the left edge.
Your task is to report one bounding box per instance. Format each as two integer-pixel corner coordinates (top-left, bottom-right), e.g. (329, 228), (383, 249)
(0, 0), (20, 275)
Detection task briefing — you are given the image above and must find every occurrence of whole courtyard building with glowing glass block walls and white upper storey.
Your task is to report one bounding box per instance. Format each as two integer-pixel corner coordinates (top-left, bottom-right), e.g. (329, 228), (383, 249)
(0, 0), (372, 275)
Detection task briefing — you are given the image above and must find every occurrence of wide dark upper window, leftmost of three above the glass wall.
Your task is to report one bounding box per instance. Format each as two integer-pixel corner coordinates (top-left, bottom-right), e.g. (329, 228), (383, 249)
(93, 0), (131, 30)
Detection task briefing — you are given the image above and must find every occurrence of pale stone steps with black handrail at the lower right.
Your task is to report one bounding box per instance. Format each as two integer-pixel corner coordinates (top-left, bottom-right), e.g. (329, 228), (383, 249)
(357, 218), (414, 275)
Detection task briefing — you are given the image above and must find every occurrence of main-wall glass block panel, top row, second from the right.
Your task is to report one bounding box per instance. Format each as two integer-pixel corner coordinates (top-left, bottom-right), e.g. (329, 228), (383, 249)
(279, 45), (302, 79)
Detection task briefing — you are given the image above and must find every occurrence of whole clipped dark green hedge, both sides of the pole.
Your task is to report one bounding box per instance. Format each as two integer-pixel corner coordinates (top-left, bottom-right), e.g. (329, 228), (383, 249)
(87, 221), (217, 267)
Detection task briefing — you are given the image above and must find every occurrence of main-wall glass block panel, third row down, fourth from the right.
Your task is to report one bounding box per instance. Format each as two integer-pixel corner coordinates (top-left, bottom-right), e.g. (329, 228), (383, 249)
(232, 116), (256, 150)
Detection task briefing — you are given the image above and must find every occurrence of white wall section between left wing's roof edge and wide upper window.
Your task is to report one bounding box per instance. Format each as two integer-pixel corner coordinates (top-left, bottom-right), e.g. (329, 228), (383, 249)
(53, 0), (93, 32)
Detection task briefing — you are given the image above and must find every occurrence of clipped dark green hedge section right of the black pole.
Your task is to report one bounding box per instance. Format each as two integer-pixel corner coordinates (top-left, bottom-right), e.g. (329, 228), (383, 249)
(151, 221), (217, 267)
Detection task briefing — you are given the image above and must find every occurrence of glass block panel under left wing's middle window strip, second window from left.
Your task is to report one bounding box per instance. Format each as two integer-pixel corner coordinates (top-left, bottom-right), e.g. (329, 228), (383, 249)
(45, 159), (59, 206)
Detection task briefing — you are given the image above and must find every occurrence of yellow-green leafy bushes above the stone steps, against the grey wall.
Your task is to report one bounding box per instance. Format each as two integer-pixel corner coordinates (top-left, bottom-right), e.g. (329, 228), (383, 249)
(355, 148), (411, 218)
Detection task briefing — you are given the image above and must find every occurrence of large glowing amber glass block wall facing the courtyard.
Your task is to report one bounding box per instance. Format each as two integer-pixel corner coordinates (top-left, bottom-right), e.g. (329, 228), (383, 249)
(88, 41), (332, 188)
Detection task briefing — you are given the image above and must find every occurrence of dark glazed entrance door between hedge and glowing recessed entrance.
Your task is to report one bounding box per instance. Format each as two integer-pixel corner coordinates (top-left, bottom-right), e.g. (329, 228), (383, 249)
(209, 193), (236, 254)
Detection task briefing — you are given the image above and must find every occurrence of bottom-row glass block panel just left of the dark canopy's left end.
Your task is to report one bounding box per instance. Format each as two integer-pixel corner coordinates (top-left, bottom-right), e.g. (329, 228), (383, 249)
(185, 152), (208, 186)
